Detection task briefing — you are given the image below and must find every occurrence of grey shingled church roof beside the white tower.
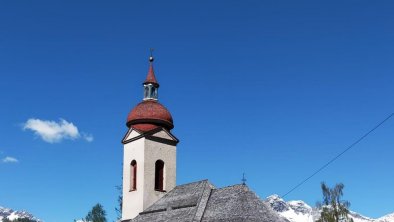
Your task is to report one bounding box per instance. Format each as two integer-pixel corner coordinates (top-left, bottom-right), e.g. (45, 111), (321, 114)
(130, 180), (286, 222)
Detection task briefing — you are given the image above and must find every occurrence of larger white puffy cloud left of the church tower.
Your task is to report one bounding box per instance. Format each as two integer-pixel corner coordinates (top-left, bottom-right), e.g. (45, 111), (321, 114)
(23, 118), (93, 143)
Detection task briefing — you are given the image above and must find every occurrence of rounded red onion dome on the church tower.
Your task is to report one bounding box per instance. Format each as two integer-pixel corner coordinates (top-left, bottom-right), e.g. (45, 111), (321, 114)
(126, 100), (174, 132)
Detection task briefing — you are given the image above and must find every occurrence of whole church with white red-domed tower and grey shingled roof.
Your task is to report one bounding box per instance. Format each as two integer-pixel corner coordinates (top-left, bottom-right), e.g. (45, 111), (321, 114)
(122, 56), (286, 222)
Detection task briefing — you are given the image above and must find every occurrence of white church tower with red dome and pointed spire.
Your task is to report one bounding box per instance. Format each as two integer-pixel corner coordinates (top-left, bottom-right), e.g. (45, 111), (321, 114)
(122, 56), (179, 221)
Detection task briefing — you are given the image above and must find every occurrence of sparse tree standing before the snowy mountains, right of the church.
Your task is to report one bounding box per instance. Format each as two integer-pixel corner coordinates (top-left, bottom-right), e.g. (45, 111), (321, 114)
(316, 182), (353, 222)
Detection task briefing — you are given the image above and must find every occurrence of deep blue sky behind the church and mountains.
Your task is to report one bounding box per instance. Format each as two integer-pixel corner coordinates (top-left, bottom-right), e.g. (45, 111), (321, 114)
(0, 1), (394, 222)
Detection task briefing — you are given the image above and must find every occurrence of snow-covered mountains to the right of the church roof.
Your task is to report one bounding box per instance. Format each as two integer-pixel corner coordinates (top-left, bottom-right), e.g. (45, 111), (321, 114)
(265, 195), (394, 222)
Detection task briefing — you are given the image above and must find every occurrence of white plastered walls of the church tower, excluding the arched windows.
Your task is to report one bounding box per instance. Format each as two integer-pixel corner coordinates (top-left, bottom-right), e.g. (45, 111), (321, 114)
(122, 129), (176, 220)
